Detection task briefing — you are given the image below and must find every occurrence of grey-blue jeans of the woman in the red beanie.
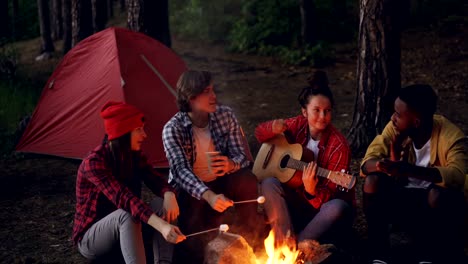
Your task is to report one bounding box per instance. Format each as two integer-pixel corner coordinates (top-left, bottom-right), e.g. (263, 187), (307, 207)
(78, 197), (173, 264)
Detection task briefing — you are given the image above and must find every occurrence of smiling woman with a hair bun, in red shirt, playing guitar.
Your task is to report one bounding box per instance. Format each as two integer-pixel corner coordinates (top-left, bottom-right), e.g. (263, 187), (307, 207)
(255, 71), (354, 256)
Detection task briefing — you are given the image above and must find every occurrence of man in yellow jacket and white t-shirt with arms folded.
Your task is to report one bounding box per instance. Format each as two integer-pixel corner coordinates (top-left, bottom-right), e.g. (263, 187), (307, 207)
(361, 85), (468, 264)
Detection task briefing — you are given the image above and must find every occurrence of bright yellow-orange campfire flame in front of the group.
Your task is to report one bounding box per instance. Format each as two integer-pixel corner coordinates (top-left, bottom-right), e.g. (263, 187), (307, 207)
(257, 230), (299, 264)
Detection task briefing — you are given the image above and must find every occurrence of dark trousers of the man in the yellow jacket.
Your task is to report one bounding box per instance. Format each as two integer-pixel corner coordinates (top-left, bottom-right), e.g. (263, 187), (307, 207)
(363, 174), (464, 263)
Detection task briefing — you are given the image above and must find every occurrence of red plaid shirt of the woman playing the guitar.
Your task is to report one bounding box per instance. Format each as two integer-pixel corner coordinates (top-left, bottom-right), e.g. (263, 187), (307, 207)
(255, 115), (354, 208)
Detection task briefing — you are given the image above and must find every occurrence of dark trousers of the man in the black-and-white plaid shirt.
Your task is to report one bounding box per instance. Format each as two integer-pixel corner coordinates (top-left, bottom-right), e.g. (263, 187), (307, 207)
(174, 169), (264, 263)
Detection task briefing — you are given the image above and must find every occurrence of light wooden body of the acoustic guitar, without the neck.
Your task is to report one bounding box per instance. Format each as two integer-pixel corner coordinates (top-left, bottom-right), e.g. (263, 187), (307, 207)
(252, 135), (314, 188)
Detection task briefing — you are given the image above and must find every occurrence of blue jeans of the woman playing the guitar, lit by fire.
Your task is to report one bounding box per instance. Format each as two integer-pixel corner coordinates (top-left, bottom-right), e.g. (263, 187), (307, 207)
(261, 178), (353, 245)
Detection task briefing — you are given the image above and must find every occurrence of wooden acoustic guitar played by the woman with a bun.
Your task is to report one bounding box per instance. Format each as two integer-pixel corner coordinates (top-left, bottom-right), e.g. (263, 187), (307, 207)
(252, 135), (356, 191)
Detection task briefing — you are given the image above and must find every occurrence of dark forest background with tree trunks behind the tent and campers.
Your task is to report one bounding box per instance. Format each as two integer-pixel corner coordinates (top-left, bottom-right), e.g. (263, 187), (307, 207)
(0, 0), (468, 264)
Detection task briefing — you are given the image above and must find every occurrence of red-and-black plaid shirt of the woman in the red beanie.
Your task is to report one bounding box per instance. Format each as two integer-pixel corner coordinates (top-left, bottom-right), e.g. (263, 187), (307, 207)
(72, 144), (173, 243)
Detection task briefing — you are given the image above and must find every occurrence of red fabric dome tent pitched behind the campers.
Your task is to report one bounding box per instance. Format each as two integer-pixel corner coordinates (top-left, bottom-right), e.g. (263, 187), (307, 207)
(16, 28), (187, 167)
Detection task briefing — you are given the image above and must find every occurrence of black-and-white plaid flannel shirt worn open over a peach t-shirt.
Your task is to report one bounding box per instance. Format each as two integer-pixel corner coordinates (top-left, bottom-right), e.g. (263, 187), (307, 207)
(162, 105), (250, 200)
